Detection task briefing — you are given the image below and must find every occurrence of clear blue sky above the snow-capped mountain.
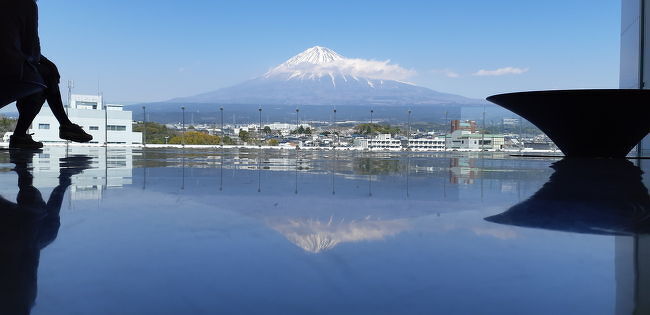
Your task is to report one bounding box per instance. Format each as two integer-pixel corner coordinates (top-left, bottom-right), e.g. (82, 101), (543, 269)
(39, 0), (620, 103)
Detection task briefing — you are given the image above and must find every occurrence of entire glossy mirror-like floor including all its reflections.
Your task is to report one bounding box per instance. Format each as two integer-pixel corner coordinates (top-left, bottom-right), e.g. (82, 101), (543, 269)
(0, 147), (650, 314)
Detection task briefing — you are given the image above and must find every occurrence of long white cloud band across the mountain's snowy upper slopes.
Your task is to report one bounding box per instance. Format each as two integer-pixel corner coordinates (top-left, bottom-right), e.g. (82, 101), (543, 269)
(269, 58), (416, 80)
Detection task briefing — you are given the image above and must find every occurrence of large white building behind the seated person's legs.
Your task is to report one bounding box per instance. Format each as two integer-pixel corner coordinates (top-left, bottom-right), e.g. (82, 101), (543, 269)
(29, 94), (142, 145)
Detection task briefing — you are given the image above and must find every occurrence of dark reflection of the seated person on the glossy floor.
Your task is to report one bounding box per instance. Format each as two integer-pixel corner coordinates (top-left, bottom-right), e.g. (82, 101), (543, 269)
(0, 150), (91, 314)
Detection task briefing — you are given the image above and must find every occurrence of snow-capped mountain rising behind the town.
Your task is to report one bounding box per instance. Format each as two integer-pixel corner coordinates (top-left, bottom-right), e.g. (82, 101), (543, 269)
(165, 46), (483, 106)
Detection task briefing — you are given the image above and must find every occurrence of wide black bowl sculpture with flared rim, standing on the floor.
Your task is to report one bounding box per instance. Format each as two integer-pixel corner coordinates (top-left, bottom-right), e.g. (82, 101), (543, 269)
(487, 89), (650, 158)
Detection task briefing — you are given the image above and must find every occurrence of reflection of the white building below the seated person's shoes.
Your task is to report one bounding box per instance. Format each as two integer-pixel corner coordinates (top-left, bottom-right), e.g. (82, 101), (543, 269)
(33, 146), (133, 200)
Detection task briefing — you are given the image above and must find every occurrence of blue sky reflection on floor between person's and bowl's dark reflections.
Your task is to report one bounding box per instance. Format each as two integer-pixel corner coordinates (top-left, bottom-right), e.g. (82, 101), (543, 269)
(0, 149), (636, 314)
